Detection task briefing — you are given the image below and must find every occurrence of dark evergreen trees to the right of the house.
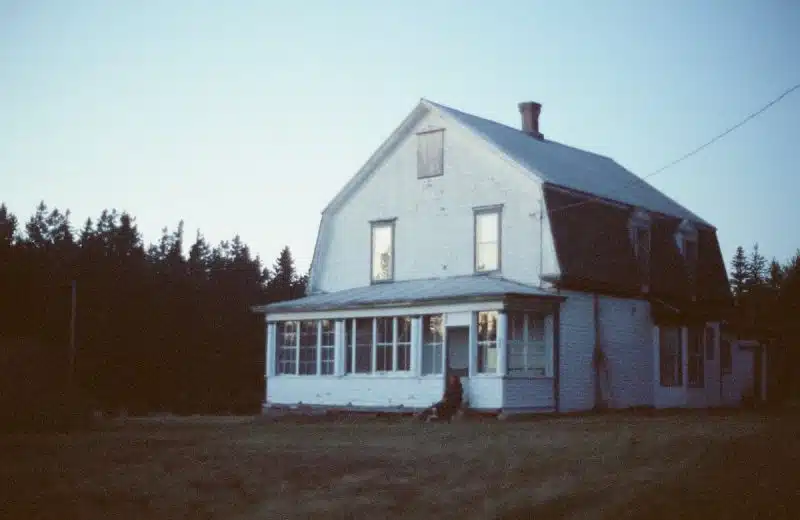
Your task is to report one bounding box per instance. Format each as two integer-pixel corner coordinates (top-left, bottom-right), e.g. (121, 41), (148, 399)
(729, 244), (800, 401)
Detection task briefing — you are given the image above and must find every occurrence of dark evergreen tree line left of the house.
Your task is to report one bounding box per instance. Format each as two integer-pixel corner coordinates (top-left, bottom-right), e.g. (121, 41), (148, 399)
(0, 202), (307, 420)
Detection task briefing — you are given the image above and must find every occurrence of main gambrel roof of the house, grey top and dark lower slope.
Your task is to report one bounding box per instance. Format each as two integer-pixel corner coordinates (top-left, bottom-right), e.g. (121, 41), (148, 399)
(302, 99), (730, 308)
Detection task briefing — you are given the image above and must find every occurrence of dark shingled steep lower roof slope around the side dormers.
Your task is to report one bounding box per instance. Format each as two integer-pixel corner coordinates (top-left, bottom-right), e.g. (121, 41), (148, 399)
(544, 185), (731, 313)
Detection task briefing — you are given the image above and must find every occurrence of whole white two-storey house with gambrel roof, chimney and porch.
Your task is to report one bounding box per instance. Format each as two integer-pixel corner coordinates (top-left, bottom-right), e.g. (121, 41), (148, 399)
(254, 99), (744, 412)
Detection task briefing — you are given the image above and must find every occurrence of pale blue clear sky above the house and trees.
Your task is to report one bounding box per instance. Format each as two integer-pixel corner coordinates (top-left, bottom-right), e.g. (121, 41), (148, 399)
(0, 0), (800, 270)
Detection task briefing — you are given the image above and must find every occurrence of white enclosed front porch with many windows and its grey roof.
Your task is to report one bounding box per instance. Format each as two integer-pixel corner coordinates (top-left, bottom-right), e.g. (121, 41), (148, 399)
(255, 276), (563, 412)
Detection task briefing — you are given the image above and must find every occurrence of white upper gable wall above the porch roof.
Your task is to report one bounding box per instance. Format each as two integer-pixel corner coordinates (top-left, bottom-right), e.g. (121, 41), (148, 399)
(314, 111), (557, 291)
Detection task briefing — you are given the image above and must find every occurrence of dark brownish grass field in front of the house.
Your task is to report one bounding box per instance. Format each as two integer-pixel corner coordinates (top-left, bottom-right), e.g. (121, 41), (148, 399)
(0, 413), (800, 520)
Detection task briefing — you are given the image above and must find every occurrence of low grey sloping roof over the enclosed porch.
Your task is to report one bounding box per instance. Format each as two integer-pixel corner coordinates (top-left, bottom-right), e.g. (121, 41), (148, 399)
(252, 275), (563, 314)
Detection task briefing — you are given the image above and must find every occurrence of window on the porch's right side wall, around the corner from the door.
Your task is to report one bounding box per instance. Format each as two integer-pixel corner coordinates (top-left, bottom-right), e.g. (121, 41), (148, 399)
(508, 312), (550, 376)
